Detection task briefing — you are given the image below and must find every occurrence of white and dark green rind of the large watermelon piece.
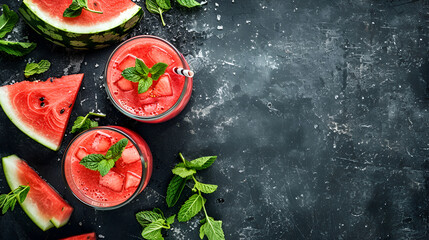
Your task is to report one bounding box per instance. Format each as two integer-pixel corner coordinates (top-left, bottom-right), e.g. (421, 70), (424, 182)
(19, 0), (144, 50)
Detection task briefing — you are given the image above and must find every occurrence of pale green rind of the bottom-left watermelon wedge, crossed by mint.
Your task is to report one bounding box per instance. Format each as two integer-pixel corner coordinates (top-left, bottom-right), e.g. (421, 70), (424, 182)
(2, 155), (54, 231)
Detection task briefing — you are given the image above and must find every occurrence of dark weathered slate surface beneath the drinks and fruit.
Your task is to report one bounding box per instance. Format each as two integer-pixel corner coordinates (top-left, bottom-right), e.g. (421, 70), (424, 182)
(0, 0), (429, 239)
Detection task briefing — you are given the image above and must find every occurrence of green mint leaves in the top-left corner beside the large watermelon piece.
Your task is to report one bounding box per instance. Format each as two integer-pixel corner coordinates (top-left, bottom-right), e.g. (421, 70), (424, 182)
(0, 4), (37, 57)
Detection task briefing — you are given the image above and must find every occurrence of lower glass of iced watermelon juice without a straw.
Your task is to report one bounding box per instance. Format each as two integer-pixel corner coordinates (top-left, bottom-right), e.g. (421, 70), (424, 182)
(62, 126), (152, 210)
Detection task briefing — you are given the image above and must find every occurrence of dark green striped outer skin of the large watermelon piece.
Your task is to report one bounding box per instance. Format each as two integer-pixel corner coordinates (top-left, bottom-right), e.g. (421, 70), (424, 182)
(18, 0), (144, 50)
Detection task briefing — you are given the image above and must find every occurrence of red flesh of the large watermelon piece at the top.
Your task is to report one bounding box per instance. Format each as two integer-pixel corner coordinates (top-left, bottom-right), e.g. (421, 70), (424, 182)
(27, 0), (136, 27)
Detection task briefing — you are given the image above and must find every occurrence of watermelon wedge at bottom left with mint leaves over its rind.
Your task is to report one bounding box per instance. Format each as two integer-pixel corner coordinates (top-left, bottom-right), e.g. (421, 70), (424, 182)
(2, 155), (73, 231)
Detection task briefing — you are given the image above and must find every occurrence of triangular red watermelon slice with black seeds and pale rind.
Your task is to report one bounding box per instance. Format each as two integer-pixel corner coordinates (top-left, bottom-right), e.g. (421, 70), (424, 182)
(0, 74), (83, 151)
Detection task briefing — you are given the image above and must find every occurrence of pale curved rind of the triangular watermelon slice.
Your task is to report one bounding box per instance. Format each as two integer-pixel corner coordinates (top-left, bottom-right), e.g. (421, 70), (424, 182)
(0, 88), (60, 151)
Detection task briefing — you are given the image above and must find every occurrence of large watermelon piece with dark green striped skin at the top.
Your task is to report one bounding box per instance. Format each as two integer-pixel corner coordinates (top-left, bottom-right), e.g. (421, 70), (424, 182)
(19, 0), (143, 50)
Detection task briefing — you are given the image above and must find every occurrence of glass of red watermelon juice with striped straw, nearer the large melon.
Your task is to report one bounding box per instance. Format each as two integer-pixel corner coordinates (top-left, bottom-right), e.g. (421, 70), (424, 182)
(104, 35), (192, 123)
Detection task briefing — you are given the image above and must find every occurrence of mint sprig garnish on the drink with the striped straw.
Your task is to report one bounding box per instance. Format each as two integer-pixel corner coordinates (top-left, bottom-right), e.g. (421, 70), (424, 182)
(122, 58), (168, 94)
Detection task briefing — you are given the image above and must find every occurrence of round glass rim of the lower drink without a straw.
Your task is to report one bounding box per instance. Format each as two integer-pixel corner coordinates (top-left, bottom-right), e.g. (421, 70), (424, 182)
(61, 126), (147, 210)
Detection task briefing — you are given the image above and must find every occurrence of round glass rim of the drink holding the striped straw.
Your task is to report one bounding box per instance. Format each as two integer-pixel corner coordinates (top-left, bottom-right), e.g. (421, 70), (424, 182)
(103, 35), (190, 122)
